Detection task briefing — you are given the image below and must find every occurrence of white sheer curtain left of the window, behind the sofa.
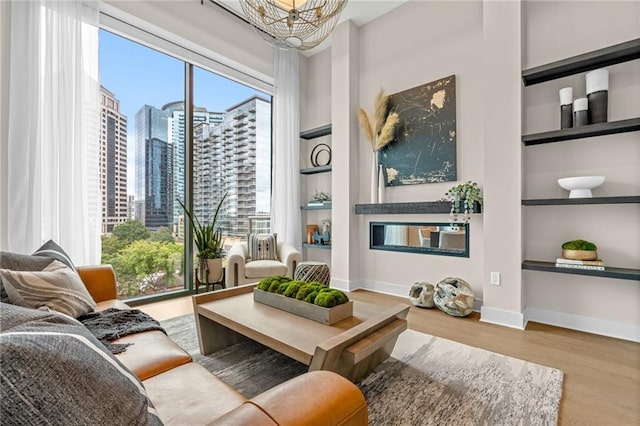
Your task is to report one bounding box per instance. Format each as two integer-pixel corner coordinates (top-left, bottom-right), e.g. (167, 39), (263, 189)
(2, 0), (101, 265)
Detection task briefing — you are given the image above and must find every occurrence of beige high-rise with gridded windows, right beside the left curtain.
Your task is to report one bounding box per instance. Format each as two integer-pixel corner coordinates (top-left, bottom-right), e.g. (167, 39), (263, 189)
(100, 86), (128, 234)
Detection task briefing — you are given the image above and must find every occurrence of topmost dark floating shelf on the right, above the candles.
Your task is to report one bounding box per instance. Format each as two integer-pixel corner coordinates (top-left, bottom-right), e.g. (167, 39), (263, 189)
(522, 39), (640, 86)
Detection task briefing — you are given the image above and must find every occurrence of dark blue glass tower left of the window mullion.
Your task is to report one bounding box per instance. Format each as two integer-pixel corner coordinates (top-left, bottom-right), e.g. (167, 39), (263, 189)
(135, 105), (173, 231)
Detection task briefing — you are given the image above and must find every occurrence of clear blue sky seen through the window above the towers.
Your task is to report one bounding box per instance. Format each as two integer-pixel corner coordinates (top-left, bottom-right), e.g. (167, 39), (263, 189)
(100, 30), (268, 194)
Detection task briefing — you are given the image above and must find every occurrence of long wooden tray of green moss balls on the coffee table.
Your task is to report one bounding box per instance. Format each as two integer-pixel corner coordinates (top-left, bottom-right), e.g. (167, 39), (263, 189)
(253, 276), (353, 325)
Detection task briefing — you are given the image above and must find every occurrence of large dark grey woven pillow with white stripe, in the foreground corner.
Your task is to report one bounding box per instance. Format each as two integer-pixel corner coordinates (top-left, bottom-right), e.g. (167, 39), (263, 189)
(0, 304), (162, 426)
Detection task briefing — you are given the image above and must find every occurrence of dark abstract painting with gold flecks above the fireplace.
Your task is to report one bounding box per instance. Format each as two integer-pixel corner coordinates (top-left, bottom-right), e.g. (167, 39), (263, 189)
(378, 75), (457, 186)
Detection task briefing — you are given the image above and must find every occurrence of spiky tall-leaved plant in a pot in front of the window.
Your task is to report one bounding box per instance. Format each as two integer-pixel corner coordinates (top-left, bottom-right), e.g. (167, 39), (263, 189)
(178, 193), (228, 283)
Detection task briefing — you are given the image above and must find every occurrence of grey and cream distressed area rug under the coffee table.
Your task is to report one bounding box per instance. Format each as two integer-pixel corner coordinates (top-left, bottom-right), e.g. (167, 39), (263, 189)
(161, 315), (563, 426)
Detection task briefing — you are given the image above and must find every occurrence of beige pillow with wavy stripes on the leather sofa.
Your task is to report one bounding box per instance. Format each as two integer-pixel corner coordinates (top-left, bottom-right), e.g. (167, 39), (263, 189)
(0, 260), (96, 318)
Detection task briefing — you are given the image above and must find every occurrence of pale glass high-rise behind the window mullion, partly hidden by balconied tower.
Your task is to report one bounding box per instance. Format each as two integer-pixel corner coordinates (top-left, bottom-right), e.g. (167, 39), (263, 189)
(162, 101), (224, 227)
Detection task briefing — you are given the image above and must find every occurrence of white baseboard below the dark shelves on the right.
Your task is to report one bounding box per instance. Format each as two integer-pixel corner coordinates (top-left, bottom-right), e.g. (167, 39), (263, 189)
(524, 306), (640, 343)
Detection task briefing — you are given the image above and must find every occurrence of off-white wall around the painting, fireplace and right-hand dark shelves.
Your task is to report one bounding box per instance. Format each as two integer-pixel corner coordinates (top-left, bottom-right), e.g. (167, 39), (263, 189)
(302, 1), (640, 339)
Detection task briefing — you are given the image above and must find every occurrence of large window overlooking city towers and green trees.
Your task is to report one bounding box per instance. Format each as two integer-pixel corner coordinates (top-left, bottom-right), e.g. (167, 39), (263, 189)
(100, 30), (271, 298)
